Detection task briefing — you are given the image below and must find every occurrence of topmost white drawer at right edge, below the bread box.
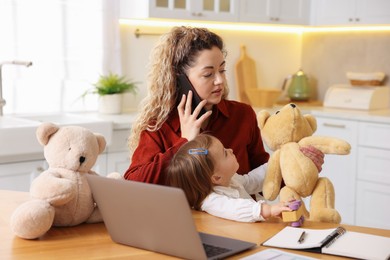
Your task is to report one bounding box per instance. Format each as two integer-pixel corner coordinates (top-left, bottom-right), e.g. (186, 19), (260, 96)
(358, 122), (390, 149)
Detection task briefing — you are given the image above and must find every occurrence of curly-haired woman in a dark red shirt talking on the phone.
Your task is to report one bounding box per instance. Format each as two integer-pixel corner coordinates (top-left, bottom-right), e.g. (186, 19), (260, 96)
(124, 26), (323, 184)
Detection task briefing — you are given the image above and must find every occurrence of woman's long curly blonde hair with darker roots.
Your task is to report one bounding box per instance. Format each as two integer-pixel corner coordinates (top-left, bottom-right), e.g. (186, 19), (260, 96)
(129, 26), (229, 150)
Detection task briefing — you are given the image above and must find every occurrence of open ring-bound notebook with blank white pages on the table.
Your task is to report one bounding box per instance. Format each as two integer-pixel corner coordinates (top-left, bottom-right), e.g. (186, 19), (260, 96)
(262, 226), (390, 260)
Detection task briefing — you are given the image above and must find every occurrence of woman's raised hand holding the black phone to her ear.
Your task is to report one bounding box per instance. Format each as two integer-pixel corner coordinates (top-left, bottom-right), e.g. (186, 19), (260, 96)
(177, 91), (211, 141)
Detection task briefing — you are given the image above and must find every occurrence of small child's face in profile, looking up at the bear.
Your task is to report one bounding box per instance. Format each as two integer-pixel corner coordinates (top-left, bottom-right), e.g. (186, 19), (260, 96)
(209, 138), (239, 186)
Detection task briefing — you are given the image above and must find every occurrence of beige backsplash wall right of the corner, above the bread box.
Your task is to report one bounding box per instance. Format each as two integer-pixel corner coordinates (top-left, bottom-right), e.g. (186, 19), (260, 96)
(302, 31), (390, 99)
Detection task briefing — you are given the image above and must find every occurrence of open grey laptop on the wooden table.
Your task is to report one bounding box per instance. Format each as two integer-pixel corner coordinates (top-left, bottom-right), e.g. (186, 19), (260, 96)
(87, 175), (256, 259)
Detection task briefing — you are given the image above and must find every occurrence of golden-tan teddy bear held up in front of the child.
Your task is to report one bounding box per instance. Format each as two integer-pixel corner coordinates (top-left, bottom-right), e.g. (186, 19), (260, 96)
(257, 103), (351, 223)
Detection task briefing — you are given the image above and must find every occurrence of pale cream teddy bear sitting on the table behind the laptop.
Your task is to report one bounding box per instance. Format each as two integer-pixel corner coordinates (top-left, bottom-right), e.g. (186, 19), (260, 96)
(10, 123), (121, 239)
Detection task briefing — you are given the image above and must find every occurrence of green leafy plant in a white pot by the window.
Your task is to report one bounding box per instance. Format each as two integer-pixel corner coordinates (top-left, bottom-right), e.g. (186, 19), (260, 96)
(83, 72), (138, 114)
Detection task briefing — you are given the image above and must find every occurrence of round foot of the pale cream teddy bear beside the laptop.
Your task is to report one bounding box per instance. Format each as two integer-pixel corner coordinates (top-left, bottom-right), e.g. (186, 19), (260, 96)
(10, 200), (55, 239)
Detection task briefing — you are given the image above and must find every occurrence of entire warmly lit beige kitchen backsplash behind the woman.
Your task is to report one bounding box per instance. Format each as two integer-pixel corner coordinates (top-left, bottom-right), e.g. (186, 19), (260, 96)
(121, 25), (390, 110)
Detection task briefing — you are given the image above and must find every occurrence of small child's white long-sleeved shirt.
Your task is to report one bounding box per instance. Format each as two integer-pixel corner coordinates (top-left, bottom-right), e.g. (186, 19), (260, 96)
(201, 164), (267, 222)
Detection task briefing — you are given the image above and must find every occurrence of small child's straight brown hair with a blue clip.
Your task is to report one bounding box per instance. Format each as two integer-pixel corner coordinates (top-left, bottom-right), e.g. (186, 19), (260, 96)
(167, 134), (215, 210)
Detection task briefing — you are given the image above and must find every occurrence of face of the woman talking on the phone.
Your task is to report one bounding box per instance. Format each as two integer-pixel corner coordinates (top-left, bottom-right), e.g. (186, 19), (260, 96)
(187, 47), (226, 110)
